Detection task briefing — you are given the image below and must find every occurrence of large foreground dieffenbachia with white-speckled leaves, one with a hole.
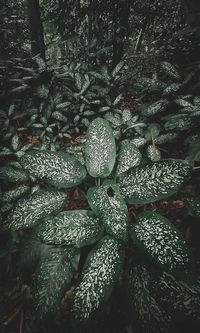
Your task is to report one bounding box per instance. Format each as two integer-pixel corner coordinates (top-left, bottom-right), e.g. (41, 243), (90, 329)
(0, 118), (198, 331)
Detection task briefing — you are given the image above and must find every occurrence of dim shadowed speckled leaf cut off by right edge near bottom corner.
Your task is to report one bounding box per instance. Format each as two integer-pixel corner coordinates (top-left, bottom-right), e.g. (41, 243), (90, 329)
(151, 272), (200, 321)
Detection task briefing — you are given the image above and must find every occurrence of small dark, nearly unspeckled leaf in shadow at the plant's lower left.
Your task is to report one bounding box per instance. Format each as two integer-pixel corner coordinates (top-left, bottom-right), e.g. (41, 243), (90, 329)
(17, 230), (51, 270)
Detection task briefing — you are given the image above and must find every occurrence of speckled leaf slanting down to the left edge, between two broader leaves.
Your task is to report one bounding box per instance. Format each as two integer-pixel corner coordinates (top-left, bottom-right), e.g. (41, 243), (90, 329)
(4, 190), (66, 230)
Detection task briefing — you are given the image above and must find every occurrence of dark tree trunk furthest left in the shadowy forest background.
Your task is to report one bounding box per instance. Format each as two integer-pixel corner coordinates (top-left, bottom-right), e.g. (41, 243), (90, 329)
(27, 0), (45, 59)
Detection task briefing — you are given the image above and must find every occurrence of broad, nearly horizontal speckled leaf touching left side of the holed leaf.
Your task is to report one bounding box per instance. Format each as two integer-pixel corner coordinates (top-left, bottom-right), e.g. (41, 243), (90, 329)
(36, 210), (104, 247)
